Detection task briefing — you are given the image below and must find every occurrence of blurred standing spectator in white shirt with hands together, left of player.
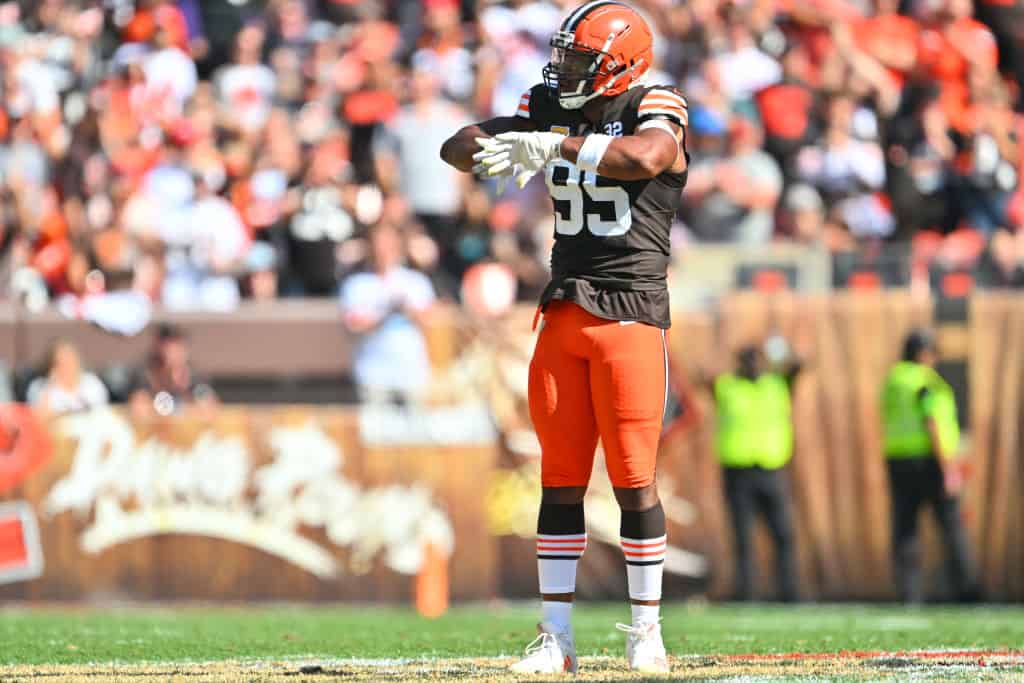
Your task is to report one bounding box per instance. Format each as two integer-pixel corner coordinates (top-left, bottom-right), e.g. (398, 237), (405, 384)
(341, 222), (434, 399)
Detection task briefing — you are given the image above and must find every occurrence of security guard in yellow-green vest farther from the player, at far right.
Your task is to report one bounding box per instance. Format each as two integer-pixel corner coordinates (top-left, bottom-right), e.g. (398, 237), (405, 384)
(882, 330), (976, 603)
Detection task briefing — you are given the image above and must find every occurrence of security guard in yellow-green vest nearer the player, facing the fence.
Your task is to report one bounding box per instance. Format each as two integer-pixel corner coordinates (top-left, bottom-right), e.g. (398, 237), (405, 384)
(714, 339), (800, 602)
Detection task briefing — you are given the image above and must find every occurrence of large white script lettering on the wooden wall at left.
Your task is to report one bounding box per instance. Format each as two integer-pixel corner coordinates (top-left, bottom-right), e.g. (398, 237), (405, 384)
(43, 411), (454, 579)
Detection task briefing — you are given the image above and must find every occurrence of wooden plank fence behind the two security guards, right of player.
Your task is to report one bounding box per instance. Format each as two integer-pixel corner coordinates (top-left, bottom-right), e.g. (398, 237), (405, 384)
(662, 292), (1024, 600)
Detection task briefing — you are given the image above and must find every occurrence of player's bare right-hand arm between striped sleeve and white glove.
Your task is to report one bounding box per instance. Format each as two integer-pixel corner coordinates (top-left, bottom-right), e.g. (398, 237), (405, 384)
(560, 121), (686, 180)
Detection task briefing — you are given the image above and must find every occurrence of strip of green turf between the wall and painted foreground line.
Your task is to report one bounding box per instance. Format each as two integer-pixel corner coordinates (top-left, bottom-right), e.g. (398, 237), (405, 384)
(0, 603), (1024, 666)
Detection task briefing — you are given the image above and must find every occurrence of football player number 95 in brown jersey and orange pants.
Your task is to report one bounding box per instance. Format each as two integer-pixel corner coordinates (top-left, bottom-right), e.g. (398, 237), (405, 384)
(441, 0), (687, 673)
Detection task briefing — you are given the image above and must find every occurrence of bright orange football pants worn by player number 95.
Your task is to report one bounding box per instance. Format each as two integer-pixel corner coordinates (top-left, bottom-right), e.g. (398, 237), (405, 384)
(529, 301), (668, 488)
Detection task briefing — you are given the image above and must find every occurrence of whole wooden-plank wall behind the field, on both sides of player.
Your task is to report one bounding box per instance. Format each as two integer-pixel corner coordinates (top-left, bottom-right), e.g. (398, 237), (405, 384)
(0, 291), (1024, 602)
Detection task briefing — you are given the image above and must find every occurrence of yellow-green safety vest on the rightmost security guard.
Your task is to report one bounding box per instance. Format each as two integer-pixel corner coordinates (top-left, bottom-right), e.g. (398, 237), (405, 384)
(882, 360), (959, 459)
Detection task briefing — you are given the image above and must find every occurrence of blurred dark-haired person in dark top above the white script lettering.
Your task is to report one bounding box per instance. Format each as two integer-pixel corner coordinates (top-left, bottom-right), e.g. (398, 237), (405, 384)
(130, 325), (217, 416)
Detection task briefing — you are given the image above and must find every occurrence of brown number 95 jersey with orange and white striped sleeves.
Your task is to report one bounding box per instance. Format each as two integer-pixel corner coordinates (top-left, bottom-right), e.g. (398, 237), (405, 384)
(517, 85), (686, 329)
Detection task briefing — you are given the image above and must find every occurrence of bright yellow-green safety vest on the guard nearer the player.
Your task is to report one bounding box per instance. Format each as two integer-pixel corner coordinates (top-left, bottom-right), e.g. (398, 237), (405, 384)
(715, 373), (793, 470)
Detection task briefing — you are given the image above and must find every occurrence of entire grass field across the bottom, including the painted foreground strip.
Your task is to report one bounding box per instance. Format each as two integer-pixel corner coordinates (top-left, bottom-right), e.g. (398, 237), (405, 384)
(0, 604), (1024, 681)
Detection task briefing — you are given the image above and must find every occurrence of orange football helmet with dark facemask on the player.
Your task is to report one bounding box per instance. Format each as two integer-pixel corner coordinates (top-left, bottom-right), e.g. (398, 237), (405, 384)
(544, 0), (654, 110)
